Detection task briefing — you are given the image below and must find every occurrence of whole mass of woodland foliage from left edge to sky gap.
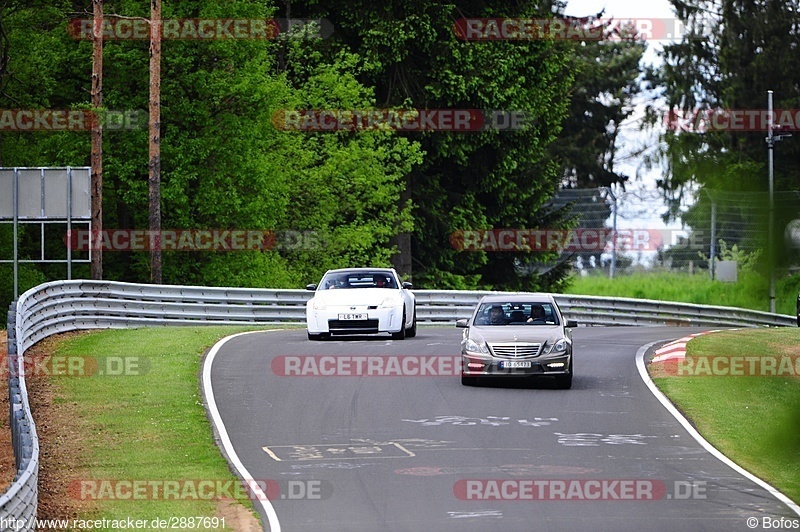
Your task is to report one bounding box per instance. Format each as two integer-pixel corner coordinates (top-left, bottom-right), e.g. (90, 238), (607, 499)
(0, 0), (656, 316)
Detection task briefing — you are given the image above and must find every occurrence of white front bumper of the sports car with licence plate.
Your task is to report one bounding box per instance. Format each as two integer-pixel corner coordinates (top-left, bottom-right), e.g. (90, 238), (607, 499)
(306, 306), (404, 334)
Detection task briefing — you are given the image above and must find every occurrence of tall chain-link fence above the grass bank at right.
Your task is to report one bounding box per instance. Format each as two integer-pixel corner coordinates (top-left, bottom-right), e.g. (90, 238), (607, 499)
(548, 187), (800, 278)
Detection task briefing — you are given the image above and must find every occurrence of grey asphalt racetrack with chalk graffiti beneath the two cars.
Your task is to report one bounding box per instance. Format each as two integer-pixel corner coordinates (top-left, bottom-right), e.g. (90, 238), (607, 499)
(204, 327), (800, 532)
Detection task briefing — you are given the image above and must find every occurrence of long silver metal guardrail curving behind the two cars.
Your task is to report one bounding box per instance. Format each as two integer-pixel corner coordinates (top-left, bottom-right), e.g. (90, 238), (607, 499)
(0, 281), (797, 530)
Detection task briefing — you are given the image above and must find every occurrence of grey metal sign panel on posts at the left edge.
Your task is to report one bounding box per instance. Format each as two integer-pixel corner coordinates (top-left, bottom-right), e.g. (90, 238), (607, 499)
(0, 167), (92, 220)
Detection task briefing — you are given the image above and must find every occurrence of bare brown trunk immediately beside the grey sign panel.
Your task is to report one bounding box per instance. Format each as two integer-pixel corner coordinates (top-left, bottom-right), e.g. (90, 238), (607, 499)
(91, 0), (103, 280)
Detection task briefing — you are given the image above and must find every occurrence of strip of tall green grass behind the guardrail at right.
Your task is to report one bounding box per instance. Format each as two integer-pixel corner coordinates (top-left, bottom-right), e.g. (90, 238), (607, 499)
(565, 272), (800, 315)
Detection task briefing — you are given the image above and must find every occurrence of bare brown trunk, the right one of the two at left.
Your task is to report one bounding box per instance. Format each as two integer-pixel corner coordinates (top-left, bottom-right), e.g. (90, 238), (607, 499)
(147, 0), (162, 284)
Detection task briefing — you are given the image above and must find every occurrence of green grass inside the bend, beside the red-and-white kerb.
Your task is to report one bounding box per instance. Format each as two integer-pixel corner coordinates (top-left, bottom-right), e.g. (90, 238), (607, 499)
(654, 328), (800, 502)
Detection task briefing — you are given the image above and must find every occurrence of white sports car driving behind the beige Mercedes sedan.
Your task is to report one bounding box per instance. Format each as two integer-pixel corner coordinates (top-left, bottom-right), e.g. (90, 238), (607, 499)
(306, 268), (417, 340)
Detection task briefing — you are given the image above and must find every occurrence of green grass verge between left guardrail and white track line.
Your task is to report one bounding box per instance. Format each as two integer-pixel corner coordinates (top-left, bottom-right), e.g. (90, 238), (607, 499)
(50, 326), (272, 530)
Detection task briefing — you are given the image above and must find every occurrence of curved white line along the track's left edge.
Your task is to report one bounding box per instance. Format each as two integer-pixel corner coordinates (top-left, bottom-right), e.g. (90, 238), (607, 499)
(203, 329), (281, 532)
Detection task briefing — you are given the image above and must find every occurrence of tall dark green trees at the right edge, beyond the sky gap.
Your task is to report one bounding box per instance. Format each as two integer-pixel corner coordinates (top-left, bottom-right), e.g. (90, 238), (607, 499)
(648, 0), (800, 266)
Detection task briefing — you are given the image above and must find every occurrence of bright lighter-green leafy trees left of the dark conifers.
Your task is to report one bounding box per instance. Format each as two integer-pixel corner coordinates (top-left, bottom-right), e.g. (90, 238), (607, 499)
(0, 0), (420, 296)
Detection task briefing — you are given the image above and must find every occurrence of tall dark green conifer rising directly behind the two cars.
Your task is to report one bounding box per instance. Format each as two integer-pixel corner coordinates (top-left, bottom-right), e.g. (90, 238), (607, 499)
(278, 0), (584, 289)
